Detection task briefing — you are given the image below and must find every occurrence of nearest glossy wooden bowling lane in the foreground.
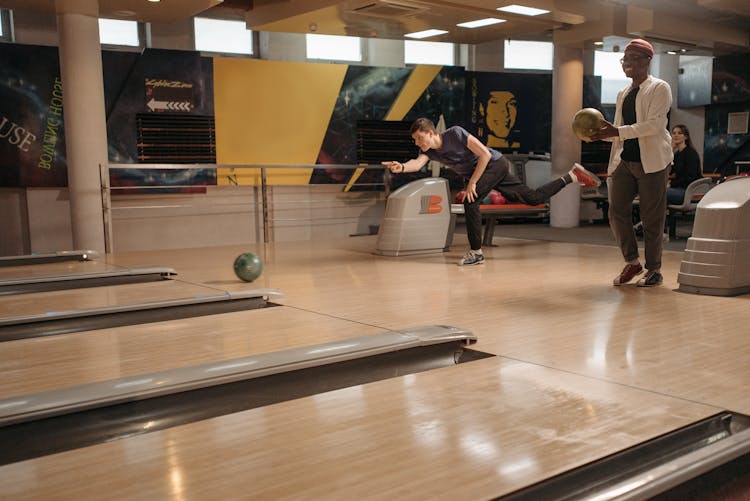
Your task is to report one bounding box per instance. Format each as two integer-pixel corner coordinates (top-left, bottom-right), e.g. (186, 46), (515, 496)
(0, 358), (717, 500)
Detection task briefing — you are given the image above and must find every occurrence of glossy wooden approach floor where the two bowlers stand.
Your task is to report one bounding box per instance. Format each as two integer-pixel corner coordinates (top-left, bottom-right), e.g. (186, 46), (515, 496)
(103, 236), (750, 414)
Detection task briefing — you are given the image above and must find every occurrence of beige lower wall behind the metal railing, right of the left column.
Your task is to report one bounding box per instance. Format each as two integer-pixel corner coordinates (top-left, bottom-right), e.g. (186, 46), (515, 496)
(112, 185), (385, 252)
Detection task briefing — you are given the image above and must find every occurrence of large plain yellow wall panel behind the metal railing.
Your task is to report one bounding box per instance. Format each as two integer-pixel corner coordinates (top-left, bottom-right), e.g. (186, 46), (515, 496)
(214, 58), (347, 185)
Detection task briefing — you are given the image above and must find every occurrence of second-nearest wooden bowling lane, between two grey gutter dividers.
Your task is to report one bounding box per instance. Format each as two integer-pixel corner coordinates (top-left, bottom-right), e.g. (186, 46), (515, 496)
(0, 306), (383, 398)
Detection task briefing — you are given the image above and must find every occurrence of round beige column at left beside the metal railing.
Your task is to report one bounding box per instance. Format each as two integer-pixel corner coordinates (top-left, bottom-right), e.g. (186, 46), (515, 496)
(55, 0), (107, 253)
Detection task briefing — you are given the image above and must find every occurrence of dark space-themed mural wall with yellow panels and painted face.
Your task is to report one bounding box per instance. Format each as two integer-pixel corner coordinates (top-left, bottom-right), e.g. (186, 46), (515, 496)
(0, 44), (616, 189)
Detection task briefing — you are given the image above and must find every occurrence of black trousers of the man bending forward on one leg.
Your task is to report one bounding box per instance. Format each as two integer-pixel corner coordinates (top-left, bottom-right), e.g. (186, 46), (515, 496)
(464, 157), (567, 250)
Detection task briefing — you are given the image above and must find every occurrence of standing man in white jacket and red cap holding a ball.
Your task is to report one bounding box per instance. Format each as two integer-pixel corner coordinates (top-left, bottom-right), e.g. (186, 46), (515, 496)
(592, 39), (673, 287)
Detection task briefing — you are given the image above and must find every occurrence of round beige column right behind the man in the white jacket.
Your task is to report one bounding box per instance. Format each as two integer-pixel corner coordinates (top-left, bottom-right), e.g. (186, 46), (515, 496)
(550, 46), (583, 228)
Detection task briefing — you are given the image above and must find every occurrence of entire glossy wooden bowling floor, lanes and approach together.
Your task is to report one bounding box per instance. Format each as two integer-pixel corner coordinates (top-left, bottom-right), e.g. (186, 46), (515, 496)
(0, 235), (750, 499)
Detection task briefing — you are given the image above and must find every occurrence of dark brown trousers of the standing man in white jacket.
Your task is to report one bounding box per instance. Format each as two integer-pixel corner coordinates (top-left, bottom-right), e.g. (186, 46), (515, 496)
(608, 160), (669, 270)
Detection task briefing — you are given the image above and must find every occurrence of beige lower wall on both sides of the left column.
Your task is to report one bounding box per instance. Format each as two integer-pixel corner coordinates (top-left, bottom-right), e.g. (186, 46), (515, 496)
(0, 185), (385, 252)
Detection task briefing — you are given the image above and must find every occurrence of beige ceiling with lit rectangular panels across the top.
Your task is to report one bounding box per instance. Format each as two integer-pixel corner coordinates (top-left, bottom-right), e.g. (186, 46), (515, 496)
(0, 0), (750, 55)
